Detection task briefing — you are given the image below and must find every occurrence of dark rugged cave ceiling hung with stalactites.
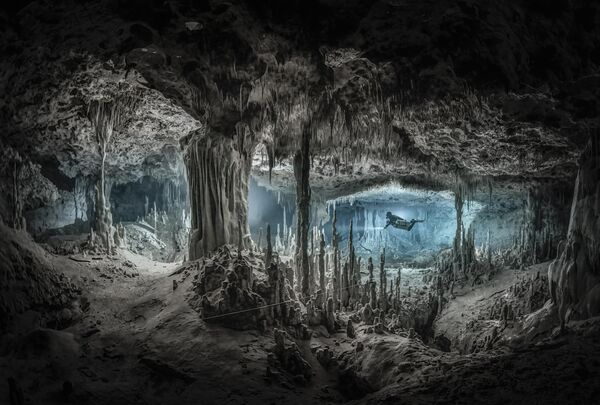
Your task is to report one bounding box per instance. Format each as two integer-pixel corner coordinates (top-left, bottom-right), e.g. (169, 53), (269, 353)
(0, 0), (600, 195)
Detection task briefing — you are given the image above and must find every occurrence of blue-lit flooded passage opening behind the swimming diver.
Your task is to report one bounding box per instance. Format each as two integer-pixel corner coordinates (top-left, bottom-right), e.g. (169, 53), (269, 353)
(248, 179), (488, 262)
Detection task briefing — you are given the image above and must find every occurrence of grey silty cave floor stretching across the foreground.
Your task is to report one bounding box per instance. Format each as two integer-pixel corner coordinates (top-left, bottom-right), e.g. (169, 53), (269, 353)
(0, 252), (600, 404)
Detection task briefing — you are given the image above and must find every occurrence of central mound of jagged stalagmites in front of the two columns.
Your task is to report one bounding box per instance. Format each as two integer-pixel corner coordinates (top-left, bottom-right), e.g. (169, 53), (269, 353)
(189, 223), (443, 338)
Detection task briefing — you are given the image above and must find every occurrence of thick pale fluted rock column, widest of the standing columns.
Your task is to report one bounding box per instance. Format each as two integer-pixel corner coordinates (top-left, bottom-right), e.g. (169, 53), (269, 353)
(181, 125), (253, 260)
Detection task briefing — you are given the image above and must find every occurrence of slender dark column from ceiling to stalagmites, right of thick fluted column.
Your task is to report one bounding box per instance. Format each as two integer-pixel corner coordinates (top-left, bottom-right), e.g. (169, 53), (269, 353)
(294, 127), (311, 298)
